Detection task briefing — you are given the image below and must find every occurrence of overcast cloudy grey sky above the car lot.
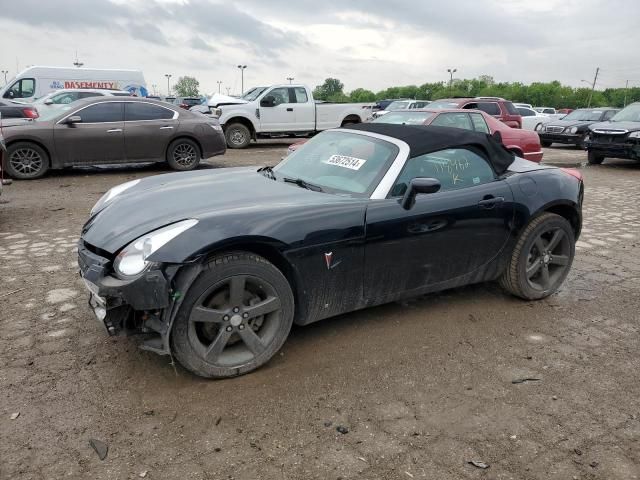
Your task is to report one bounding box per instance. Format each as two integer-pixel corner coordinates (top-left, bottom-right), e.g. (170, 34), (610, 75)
(0, 0), (640, 93)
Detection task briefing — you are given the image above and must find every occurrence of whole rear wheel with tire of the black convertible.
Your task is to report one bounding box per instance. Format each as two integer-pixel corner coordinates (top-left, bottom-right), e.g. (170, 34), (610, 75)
(500, 213), (575, 300)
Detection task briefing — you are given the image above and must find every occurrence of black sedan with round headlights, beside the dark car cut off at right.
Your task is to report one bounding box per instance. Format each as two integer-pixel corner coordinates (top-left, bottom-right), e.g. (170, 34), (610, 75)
(538, 107), (620, 148)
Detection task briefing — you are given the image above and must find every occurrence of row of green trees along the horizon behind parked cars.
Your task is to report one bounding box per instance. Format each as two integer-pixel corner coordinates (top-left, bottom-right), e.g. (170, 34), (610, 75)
(313, 75), (640, 108)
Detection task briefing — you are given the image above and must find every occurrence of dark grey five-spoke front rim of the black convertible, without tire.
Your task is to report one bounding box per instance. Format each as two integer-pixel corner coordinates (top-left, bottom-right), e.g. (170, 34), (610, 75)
(188, 275), (284, 368)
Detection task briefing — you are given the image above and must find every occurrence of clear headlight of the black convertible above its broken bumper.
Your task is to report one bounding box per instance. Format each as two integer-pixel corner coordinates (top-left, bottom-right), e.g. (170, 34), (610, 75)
(113, 219), (198, 277)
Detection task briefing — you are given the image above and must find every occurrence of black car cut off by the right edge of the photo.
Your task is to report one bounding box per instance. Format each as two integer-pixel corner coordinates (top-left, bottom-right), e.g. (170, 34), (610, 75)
(585, 102), (640, 164)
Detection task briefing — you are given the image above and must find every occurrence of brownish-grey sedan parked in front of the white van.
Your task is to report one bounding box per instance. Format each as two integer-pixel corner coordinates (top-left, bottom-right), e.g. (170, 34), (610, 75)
(3, 97), (226, 179)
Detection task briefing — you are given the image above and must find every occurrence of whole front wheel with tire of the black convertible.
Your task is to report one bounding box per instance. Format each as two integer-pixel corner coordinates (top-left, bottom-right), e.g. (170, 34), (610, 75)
(171, 252), (295, 378)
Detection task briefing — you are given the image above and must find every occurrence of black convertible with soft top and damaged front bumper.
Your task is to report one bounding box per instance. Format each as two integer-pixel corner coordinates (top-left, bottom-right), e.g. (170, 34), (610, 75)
(78, 124), (583, 377)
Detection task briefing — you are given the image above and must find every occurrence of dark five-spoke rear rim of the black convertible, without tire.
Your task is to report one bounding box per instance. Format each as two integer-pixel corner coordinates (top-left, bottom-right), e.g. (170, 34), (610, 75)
(526, 228), (571, 291)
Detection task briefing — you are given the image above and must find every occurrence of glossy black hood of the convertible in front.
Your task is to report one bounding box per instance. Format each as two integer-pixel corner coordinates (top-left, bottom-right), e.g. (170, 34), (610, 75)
(82, 167), (352, 254)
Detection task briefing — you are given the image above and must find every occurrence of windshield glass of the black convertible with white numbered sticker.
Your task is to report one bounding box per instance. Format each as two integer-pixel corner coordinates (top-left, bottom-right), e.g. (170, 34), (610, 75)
(274, 131), (399, 197)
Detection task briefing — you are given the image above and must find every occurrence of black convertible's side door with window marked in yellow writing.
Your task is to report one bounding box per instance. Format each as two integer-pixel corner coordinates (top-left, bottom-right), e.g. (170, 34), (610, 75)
(364, 148), (514, 298)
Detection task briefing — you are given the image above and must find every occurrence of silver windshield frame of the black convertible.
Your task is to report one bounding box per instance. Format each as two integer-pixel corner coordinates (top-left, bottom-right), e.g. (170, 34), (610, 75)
(273, 128), (411, 200)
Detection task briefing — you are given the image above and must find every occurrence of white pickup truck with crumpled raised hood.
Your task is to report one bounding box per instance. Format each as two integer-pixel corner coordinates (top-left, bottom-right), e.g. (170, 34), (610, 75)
(206, 85), (371, 148)
